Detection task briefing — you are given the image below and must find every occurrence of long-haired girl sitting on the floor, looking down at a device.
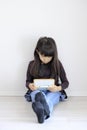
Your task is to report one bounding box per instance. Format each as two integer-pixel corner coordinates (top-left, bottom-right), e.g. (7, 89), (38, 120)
(25, 37), (69, 123)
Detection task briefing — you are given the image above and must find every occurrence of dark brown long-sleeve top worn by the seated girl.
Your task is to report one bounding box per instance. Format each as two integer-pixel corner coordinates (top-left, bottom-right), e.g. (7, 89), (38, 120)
(26, 61), (69, 90)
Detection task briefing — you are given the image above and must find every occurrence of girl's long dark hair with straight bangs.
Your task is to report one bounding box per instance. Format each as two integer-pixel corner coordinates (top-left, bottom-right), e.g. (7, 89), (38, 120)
(31, 37), (60, 78)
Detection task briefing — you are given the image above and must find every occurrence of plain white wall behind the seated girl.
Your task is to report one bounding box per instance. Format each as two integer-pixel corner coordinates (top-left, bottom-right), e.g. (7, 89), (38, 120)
(0, 0), (87, 96)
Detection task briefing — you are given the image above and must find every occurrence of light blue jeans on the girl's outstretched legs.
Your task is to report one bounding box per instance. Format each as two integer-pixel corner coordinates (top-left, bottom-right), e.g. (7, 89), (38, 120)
(31, 90), (61, 114)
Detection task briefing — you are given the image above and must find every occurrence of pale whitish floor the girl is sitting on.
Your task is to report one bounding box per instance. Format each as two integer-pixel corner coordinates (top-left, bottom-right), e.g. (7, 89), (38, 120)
(0, 97), (87, 130)
